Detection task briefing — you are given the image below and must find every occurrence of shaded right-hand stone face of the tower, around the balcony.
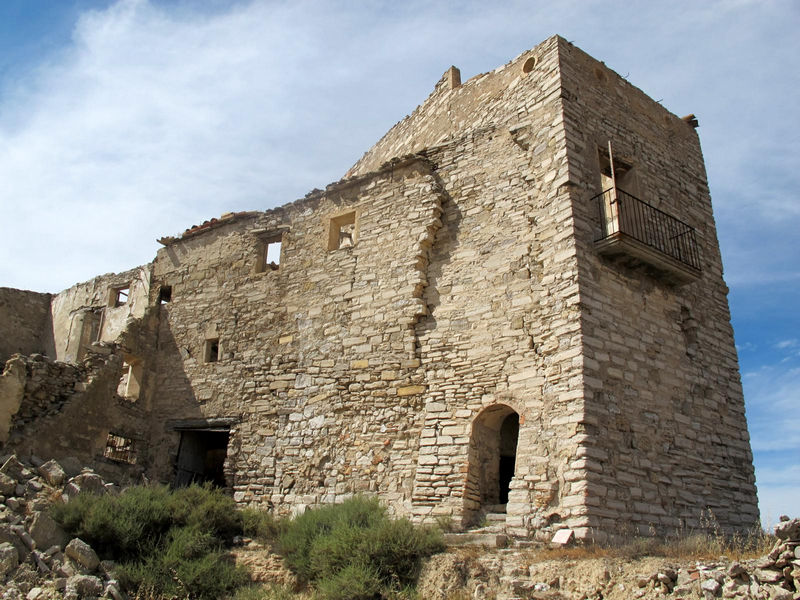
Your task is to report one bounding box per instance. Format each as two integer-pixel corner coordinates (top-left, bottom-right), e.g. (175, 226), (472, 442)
(560, 40), (758, 533)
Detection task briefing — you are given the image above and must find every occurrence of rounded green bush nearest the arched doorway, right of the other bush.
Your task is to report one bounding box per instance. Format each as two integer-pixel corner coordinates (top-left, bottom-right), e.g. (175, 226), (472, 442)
(278, 497), (444, 600)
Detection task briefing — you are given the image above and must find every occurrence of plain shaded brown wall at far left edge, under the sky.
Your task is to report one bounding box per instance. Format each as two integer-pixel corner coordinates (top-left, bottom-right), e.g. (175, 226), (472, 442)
(0, 287), (55, 362)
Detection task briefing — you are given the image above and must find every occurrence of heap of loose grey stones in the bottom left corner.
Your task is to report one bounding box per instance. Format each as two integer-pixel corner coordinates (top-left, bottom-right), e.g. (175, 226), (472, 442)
(0, 455), (125, 600)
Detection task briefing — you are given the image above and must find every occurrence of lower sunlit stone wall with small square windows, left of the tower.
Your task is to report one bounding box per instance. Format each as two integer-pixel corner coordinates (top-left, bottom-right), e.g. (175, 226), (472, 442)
(149, 158), (442, 512)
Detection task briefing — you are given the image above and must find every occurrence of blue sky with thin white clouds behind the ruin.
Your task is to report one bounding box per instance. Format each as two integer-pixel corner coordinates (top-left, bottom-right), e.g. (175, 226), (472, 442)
(0, 0), (800, 522)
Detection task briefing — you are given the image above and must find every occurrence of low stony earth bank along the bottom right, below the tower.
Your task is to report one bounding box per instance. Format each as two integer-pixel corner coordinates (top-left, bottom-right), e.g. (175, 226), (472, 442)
(418, 517), (800, 600)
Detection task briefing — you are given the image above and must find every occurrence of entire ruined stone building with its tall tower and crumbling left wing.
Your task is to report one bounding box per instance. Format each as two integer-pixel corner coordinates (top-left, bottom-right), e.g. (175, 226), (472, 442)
(0, 36), (758, 540)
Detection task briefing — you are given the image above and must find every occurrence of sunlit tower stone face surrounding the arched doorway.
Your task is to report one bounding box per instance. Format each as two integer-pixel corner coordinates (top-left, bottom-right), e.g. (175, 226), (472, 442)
(350, 38), (585, 535)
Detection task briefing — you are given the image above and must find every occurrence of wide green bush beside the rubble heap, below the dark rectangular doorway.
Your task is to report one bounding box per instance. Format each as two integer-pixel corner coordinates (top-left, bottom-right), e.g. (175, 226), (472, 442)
(53, 486), (249, 600)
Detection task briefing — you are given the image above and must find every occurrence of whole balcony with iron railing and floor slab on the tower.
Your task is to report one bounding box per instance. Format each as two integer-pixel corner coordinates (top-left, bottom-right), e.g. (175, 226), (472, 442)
(592, 188), (700, 285)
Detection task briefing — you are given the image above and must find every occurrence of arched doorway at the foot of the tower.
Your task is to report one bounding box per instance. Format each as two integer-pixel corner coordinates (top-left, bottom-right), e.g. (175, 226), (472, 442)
(464, 404), (519, 521)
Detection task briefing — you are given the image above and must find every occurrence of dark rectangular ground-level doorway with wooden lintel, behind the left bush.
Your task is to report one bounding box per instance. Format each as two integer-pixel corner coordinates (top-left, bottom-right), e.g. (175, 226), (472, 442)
(175, 428), (230, 487)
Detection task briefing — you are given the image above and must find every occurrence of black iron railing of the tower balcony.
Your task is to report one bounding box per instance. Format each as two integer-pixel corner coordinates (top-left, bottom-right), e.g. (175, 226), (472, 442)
(592, 188), (700, 270)
